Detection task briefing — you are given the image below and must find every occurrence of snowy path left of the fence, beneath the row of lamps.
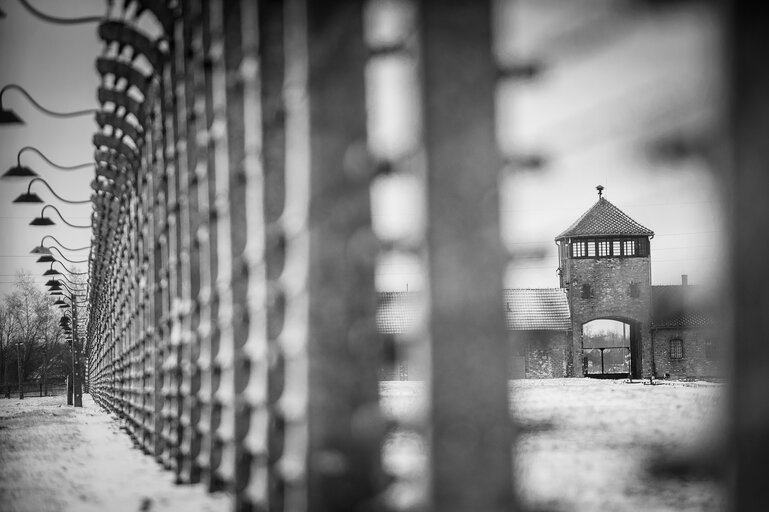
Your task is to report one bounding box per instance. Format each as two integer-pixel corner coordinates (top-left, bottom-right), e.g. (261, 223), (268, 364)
(0, 395), (229, 512)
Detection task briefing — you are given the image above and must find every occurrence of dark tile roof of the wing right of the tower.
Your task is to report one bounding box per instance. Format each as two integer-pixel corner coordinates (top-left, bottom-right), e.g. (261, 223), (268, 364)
(652, 285), (714, 329)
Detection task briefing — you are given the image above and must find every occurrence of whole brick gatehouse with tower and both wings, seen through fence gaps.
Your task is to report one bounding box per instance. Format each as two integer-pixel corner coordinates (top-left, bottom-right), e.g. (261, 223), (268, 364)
(377, 186), (721, 380)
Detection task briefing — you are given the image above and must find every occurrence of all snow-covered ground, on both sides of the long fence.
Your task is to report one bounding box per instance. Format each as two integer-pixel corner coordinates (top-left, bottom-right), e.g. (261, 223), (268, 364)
(0, 379), (722, 512)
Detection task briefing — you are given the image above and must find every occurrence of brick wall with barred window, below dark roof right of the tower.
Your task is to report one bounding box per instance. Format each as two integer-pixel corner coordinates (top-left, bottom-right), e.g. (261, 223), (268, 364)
(652, 329), (723, 379)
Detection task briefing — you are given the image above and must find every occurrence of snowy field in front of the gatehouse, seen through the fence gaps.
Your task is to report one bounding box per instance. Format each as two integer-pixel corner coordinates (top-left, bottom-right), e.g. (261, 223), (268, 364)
(381, 379), (724, 512)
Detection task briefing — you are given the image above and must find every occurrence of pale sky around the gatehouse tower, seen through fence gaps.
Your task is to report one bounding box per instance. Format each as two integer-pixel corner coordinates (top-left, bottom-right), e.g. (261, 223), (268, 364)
(375, 0), (723, 290)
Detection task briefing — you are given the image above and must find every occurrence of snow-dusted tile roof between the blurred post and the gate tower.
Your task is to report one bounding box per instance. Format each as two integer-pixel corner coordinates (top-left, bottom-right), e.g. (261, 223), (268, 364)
(505, 288), (571, 331)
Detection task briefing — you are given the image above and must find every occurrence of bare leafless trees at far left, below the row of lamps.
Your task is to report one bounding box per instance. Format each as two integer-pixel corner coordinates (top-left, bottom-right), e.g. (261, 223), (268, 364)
(0, 274), (72, 398)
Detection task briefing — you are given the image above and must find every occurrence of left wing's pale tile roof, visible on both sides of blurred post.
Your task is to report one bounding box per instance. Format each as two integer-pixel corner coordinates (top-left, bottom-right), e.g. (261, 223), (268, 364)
(376, 288), (571, 334)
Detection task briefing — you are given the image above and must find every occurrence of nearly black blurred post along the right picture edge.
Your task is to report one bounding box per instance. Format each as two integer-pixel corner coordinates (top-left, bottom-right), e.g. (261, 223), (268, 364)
(722, 0), (769, 512)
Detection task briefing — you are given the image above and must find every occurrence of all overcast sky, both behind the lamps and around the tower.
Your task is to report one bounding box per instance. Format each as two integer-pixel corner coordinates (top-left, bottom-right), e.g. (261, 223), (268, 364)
(0, 0), (721, 295)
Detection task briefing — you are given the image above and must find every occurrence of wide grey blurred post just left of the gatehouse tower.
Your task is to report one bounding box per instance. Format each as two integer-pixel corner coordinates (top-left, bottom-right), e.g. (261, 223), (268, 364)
(421, 0), (513, 512)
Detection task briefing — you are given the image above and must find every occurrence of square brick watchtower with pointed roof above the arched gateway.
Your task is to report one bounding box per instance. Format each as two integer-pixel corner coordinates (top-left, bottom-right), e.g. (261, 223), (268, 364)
(555, 185), (654, 378)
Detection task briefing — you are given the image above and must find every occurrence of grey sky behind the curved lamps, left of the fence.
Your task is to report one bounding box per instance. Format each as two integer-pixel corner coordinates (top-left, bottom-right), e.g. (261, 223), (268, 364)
(0, 0), (106, 295)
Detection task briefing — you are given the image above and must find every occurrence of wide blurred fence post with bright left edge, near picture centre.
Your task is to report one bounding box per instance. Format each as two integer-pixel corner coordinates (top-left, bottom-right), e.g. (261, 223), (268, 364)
(278, 0), (384, 512)
